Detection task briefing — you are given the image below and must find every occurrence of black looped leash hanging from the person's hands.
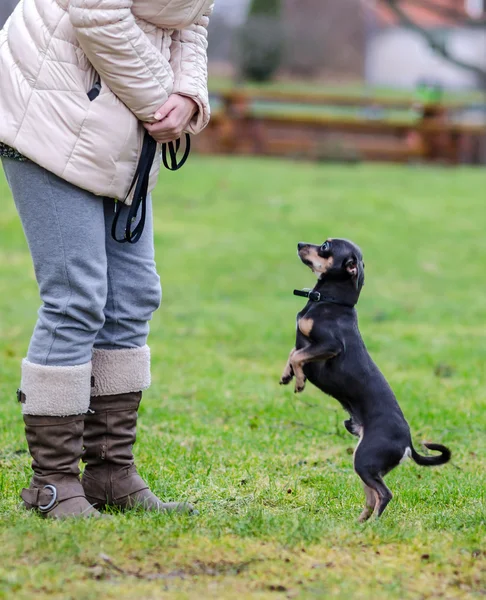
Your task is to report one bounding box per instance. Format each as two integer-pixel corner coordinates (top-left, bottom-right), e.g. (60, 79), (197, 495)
(111, 131), (191, 244)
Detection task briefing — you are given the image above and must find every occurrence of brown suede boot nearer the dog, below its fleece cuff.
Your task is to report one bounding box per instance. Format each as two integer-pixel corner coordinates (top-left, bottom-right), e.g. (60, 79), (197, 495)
(81, 392), (197, 514)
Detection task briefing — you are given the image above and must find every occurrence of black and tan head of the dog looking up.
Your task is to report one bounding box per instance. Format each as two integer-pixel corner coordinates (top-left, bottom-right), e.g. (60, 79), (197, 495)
(297, 238), (364, 291)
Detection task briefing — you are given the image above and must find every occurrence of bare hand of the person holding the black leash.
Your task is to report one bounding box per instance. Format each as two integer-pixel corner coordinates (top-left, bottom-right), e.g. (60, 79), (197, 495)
(143, 94), (198, 144)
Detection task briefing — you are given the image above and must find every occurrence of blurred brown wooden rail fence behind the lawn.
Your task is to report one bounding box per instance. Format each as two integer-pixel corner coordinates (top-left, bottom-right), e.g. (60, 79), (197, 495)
(195, 90), (486, 164)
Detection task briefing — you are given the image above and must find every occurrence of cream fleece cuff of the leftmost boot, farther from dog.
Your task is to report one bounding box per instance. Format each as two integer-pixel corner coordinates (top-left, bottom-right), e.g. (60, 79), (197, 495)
(17, 359), (91, 417)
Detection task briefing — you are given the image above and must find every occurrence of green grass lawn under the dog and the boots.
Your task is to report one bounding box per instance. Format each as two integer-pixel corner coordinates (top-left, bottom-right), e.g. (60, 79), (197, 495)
(0, 157), (486, 600)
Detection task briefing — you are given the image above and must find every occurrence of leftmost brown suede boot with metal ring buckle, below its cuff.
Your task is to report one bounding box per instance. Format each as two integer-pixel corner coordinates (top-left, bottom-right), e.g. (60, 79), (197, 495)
(21, 414), (101, 518)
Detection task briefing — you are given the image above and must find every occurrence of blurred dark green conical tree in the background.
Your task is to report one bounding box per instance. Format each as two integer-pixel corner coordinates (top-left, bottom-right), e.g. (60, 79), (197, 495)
(237, 0), (285, 81)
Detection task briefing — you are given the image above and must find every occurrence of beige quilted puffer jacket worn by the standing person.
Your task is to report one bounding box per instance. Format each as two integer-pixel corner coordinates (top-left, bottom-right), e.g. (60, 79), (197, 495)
(0, 0), (213, 199)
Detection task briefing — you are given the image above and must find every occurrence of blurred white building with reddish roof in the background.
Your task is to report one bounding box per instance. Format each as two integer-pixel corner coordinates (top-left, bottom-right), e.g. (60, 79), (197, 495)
(366, 0), (486, 88)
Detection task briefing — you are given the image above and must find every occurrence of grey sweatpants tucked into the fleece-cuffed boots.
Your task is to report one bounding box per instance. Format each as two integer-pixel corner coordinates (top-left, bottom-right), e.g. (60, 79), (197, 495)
(2, 158), (161, 414)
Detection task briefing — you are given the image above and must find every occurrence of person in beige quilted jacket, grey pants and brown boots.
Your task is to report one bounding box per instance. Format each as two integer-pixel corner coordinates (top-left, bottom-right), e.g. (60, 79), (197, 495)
(0, 0), (212, 517)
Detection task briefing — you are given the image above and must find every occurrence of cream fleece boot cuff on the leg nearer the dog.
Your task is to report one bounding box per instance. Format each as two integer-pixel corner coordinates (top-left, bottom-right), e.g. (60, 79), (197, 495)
(91, 346), (150, 396)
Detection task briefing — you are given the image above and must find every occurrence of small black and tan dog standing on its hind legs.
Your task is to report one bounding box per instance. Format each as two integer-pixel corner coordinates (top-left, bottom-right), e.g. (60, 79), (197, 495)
(280, 239), (451, 521)
